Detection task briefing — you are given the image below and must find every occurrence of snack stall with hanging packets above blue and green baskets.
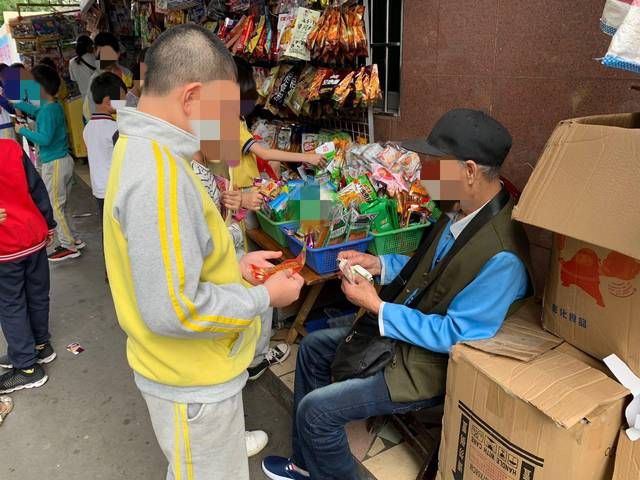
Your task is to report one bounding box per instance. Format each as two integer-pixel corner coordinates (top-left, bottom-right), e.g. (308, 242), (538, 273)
(205, 0), (440, 343)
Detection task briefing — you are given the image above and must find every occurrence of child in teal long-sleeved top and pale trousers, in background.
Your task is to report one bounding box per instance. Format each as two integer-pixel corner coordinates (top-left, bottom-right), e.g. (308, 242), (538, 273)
(15, 65), (85, 262)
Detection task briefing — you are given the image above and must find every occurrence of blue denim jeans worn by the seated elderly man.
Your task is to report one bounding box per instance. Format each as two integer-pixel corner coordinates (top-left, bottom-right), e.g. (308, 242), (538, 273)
(292, 328), (442, 480)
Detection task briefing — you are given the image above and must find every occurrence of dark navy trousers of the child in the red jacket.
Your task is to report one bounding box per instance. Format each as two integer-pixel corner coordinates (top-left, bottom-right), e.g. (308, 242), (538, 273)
(0, 248), (50, 369)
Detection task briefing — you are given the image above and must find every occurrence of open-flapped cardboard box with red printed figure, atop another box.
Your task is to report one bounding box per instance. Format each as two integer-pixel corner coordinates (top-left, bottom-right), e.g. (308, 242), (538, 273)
(513, 114), (640, 372)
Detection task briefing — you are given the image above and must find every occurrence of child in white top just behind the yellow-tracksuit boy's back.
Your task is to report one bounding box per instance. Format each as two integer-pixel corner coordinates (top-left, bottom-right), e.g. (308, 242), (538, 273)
(82, 72), (127, 222)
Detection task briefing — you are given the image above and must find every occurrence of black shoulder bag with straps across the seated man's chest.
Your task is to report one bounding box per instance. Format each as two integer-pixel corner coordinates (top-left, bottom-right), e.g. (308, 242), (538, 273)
(331, 188), (510, 382)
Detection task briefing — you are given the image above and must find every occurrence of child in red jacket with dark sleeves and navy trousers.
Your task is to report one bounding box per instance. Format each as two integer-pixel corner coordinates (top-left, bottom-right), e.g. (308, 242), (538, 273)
(0, 140), (56, 394)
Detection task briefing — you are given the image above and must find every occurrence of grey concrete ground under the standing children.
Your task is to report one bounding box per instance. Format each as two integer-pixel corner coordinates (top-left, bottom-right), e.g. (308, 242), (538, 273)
(0, 178), (291, 480)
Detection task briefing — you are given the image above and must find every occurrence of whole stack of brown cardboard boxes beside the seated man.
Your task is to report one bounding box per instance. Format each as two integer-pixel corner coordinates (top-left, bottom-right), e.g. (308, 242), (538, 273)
(439, 114), (640, 480)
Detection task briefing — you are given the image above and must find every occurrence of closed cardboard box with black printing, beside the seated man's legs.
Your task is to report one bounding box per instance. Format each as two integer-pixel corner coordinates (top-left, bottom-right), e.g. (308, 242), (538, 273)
(438, 316), (628, 480)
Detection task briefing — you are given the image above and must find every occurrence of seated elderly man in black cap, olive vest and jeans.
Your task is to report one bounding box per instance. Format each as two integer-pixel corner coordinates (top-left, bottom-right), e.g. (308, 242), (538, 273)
(263, 109), (532, 480)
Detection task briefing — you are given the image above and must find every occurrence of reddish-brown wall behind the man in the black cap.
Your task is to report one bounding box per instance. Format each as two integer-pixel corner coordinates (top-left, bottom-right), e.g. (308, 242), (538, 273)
(375, 0), (640, 292)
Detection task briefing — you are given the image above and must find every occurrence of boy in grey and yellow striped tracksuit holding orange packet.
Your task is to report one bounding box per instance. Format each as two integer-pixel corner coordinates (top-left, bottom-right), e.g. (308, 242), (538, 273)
(104, 25), (303, 480)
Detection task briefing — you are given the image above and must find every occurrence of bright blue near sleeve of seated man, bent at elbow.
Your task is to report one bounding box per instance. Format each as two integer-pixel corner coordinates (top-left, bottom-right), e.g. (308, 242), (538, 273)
(378, 252), (529, 353)
